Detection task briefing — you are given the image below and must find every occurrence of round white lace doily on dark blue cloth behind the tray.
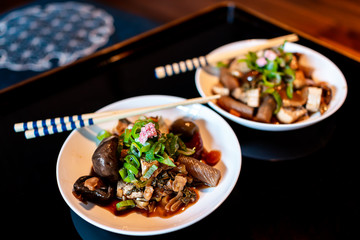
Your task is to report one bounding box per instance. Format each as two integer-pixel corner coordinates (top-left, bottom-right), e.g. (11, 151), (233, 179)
(0, 2), (114, 71)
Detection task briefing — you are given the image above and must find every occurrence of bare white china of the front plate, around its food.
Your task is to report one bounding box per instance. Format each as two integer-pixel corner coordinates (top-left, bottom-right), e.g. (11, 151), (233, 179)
(56, 95), (241, 235)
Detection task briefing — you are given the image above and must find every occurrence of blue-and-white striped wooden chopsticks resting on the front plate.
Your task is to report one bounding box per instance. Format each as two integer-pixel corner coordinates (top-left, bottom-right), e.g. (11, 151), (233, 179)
(14, 95), (220, 139)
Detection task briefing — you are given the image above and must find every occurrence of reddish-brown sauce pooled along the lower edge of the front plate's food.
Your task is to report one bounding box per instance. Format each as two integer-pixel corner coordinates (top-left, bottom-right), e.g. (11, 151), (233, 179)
(101, 188), (199, 218)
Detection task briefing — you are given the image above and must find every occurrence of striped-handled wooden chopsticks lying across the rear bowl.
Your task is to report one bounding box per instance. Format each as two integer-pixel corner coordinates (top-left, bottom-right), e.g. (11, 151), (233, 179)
(155, 34), (299, 79)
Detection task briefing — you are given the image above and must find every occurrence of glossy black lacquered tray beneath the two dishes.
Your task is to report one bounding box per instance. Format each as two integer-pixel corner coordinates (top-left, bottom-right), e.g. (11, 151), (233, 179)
(0, 4), (360, 239)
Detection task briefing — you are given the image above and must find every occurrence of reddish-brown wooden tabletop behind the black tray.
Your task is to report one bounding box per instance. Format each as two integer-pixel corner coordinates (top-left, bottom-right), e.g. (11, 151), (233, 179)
(103, 0), (360, 61)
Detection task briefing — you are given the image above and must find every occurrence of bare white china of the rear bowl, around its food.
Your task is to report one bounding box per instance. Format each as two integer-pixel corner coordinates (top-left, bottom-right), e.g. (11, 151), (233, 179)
(195, 39), (347, 131)
